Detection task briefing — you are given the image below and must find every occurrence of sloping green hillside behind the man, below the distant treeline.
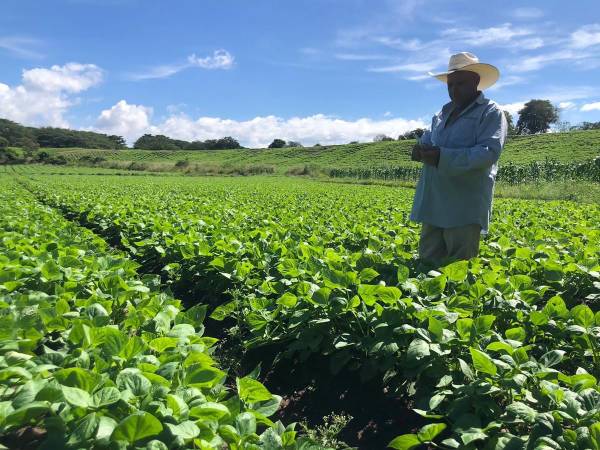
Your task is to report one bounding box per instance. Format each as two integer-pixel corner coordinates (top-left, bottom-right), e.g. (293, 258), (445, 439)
(48, 130), (600, 172)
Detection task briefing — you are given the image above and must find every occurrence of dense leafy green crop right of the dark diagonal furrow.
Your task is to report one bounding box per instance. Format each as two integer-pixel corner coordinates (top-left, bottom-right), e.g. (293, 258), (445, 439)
(15, 176), (600, 449)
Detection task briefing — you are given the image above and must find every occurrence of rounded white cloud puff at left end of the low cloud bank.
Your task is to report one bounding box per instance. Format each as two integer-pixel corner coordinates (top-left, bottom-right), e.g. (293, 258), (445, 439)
(95, 100), (152, 142)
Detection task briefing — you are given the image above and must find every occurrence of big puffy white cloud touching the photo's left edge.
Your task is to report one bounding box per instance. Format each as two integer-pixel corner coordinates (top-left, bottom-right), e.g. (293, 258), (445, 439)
(0, 63), (103, 127)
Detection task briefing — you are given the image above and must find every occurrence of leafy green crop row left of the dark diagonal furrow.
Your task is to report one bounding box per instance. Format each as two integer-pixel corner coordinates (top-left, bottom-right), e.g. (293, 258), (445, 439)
(0, 177), (328, 450)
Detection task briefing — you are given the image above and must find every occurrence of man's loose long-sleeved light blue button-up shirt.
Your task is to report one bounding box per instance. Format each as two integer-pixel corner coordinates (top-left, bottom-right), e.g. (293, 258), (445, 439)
(410, 92), (508, 232)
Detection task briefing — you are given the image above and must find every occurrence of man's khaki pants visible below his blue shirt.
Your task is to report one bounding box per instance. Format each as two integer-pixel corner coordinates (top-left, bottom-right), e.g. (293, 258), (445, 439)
(419, 223), (481, 264)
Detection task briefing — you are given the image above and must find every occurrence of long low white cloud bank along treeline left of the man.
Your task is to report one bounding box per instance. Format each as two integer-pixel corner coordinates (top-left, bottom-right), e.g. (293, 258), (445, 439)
(95, 100), (427, 147)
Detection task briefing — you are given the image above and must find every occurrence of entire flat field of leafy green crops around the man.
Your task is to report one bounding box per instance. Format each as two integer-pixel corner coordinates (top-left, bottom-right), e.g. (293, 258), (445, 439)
(0, 167), (600, 449)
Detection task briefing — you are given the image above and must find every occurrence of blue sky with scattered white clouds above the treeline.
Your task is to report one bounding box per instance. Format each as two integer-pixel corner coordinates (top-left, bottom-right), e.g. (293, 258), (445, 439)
(0, 0), (600, 147)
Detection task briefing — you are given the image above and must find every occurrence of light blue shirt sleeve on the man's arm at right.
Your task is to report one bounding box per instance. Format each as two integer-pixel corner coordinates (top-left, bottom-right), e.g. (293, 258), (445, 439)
(438, 107), (508, 176)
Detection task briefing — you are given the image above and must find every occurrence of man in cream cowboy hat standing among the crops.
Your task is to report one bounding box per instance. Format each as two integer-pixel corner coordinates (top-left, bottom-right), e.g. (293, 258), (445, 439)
(410, 52), (508, 264)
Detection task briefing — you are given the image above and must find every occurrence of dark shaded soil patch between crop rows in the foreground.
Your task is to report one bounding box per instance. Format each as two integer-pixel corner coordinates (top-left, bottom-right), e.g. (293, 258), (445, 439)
(244, 351), (427, 450)
